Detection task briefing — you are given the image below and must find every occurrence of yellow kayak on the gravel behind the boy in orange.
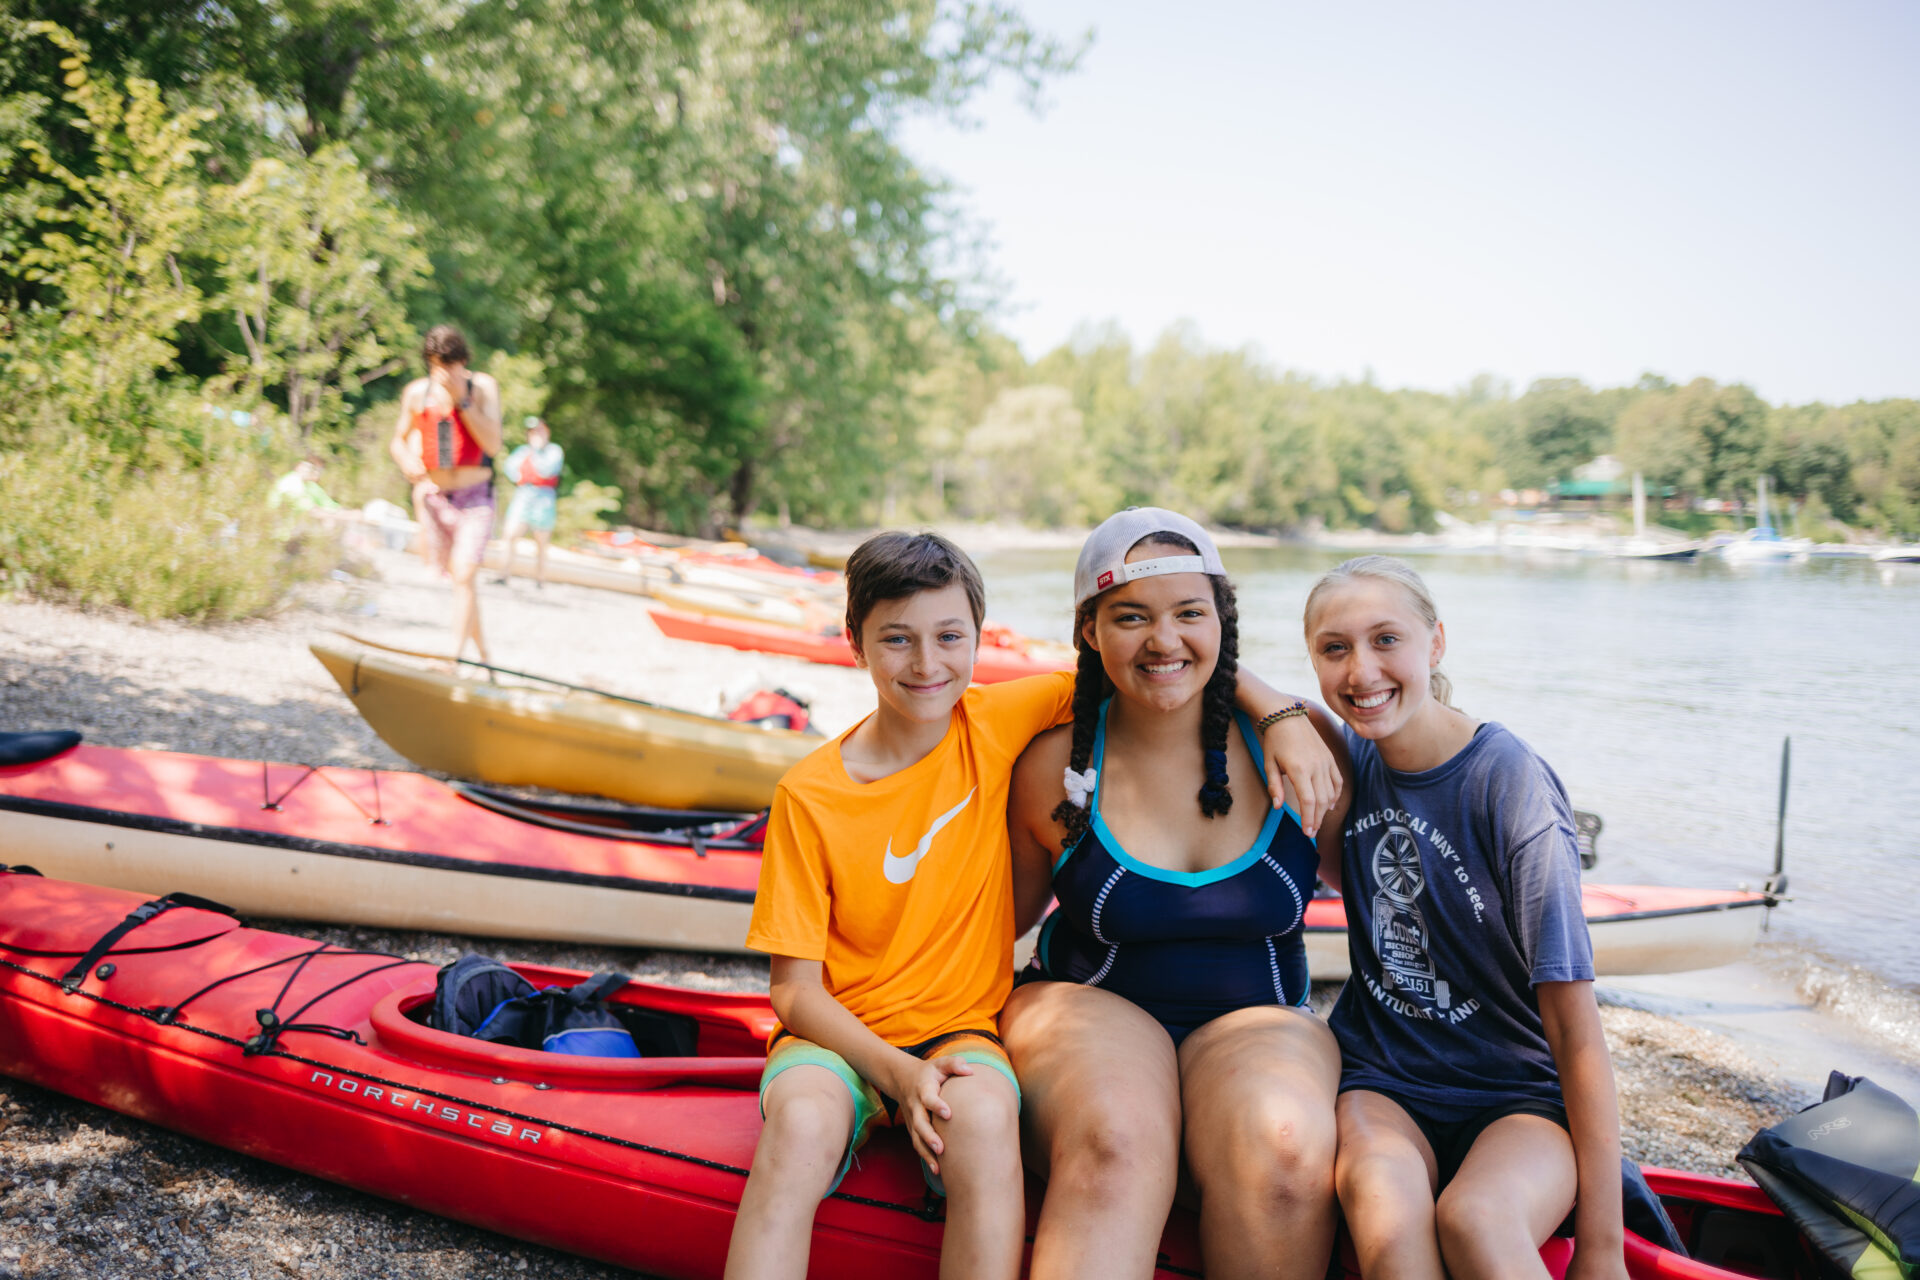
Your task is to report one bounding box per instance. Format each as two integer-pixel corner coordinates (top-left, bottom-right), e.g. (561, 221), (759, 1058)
(311, 637), (822, 810)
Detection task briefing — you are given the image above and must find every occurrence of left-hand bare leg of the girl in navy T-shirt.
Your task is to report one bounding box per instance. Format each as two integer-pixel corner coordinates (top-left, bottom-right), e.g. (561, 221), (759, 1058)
(1334, 1090), (1446, 1280)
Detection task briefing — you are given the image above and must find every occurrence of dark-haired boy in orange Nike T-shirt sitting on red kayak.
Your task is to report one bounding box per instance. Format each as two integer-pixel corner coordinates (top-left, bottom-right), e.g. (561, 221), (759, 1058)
(726, 533), (1338, 1280)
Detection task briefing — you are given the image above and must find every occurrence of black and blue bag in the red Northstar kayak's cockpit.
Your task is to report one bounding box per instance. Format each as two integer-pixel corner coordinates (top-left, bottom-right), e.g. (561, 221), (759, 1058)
(426, 952), (641, 1057)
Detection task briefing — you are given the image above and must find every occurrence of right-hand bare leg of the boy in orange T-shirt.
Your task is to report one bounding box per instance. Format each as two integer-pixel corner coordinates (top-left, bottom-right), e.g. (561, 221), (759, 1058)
(933, 1063), (1027, 1280)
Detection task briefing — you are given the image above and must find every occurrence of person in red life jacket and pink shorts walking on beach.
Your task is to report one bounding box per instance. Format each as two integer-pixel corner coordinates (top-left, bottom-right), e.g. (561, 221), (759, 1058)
(388, 324), (501, 662)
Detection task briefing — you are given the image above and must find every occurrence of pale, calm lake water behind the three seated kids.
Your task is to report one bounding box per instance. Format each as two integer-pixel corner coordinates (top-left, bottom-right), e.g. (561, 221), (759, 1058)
(981, 547), (1920, 997)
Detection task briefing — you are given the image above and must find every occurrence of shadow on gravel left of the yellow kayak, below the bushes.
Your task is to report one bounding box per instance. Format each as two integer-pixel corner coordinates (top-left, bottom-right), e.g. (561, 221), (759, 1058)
(0, 652), (413, 770)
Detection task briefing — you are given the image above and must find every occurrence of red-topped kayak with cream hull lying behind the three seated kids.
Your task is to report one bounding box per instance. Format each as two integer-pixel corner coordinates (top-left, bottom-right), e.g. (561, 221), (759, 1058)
(0, 735), (1768, 981)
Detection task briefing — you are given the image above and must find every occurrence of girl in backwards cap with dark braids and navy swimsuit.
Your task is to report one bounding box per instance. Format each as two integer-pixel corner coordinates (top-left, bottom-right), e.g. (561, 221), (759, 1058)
(1000, 507), (1344, 1280)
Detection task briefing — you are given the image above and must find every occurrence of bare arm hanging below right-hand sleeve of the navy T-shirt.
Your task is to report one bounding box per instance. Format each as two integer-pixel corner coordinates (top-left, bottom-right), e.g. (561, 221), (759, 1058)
(1534, 983), (1626, 1280)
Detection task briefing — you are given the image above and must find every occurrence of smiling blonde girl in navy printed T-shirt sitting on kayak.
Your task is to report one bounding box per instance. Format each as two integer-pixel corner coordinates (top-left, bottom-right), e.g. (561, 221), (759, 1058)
(1304, 557), (1626, 1280)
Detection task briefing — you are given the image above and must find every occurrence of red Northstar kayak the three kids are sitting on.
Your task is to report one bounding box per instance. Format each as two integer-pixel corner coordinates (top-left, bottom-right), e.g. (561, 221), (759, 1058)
(0, 869), (1811, 1280)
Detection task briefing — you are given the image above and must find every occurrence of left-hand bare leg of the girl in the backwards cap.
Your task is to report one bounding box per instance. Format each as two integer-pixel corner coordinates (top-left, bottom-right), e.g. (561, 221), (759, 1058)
(1000, 983), (1181, 1280)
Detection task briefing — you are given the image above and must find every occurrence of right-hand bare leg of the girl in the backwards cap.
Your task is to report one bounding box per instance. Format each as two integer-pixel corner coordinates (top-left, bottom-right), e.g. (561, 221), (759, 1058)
(1179, 1007), (1340, 1280)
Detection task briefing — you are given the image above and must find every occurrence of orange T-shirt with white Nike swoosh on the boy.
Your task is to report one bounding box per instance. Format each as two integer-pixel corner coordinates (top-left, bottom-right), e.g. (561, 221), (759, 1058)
(747, 672), (1073, 1048)
